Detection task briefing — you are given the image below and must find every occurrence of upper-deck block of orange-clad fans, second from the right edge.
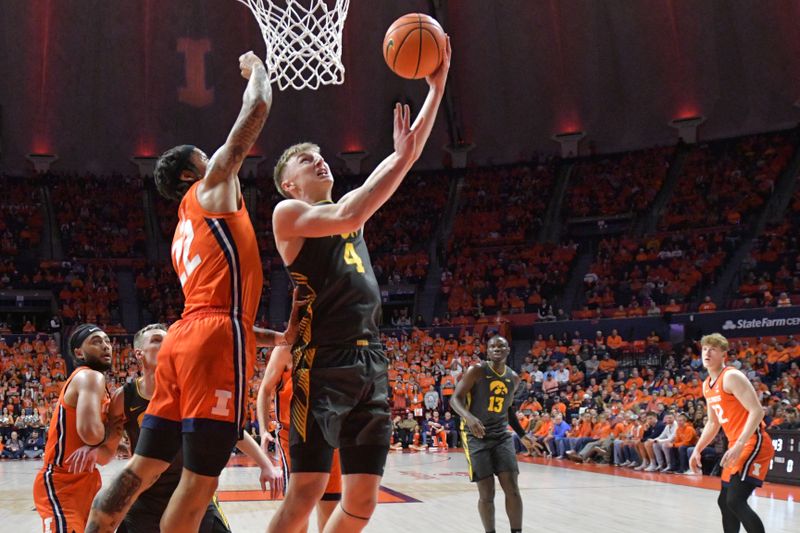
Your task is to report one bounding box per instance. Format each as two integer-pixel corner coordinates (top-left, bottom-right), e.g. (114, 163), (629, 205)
(563, 146), (675, 218)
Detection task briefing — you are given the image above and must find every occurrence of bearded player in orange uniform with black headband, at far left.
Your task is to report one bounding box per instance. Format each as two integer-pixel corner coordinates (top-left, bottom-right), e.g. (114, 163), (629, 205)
(33, 324), (122, 533)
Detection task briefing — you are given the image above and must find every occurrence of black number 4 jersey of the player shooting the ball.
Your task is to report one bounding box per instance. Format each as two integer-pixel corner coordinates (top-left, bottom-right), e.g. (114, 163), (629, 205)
(287, 218), (381, 347)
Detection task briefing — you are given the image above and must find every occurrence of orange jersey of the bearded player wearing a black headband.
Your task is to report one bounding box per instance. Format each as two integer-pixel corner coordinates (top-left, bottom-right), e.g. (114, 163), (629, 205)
(42, 366), (111, 472)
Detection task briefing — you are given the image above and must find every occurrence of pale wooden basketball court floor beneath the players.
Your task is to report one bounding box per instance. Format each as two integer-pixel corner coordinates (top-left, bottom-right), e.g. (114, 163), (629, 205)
(0, 451), (800, 533)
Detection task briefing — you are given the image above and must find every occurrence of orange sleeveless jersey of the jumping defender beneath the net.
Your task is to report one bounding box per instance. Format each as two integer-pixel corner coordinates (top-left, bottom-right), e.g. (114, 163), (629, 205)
(172, 181), (264, 325)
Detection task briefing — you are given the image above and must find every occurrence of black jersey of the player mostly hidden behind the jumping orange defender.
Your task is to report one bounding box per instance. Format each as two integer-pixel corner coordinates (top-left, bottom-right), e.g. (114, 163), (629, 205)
(122, 380), (183, 516)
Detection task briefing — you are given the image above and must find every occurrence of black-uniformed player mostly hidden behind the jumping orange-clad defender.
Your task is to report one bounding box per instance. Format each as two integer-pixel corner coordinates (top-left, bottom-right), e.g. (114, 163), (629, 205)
(111, 324), (280, 533)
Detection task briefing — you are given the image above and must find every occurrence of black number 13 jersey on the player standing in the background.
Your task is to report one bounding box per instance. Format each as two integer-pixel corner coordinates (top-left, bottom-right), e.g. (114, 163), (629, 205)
(461, 361), (515, 437)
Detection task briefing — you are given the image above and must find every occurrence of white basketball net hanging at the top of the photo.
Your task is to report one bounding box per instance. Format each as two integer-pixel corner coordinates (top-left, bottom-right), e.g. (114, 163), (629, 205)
(237, 0), (350, 91)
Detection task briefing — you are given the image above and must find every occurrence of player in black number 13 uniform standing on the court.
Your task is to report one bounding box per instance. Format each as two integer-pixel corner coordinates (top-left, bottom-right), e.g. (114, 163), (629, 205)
(450, 335), (533, 533)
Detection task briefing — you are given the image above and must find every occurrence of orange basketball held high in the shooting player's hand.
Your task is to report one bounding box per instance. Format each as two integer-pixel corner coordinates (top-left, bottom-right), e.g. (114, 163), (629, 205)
(383, 13), (447, 80)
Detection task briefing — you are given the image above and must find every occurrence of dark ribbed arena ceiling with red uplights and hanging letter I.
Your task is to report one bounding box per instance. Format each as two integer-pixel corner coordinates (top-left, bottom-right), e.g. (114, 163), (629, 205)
(0, 0), (800, 172)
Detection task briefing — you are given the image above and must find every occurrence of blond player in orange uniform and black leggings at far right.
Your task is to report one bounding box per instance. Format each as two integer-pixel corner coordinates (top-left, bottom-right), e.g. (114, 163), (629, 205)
(689, 333), (775, 533)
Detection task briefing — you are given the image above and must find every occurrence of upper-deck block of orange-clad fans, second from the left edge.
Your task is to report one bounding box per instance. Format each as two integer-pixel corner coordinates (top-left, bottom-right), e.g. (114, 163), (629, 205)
(49, 174), (145, 259)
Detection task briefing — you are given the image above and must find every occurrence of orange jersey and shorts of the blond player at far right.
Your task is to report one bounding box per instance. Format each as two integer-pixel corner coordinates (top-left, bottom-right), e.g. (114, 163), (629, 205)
(703, 367), (774, 486)
